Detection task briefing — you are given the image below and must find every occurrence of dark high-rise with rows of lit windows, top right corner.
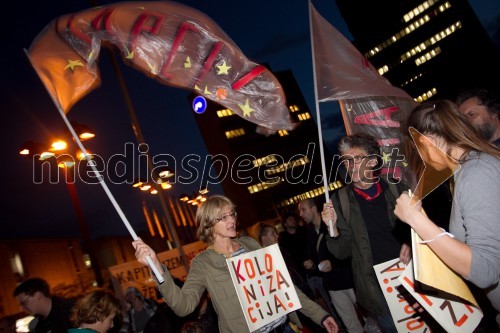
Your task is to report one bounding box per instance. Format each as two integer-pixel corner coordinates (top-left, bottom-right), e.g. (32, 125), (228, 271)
(336, 0), (500, 102)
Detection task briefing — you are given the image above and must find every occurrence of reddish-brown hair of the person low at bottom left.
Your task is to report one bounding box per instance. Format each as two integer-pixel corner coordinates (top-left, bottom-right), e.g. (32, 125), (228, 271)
(73, 289), (121, 326)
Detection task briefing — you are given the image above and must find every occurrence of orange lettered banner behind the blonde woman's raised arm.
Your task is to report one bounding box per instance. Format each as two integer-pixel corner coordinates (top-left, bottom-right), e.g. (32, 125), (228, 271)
(109, 241), (207, 302)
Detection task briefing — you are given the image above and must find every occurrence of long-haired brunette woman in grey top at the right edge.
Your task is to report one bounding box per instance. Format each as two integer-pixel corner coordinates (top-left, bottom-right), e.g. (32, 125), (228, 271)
(394, 100), (500, 326)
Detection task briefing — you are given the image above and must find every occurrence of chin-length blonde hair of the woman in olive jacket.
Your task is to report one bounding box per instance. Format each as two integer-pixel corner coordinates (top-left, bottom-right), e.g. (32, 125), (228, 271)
(196, 195), (235, 245)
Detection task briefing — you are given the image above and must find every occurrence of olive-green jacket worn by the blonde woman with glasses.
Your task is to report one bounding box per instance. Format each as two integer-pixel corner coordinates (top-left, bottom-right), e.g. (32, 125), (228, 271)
(154, 237), (328, 333)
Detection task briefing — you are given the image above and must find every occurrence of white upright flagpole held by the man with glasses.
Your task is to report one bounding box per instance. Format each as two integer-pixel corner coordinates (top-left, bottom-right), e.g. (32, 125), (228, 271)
(308, 0), (336, 237)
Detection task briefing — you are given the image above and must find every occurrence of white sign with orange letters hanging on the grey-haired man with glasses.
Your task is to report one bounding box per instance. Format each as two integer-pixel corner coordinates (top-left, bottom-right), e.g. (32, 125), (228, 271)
(373, 258), (431, 333)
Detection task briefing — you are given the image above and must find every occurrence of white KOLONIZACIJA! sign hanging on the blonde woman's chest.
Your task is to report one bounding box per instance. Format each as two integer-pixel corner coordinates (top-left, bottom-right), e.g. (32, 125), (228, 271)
(227, 244), (302, 332)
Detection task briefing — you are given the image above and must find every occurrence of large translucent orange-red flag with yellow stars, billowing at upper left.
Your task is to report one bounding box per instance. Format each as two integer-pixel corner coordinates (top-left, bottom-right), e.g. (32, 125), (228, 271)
(28, 1), (294, 132)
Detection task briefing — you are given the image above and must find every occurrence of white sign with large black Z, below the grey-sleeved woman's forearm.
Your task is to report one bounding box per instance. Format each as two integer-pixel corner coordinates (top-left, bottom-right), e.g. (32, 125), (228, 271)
(398, 265), (483, 333)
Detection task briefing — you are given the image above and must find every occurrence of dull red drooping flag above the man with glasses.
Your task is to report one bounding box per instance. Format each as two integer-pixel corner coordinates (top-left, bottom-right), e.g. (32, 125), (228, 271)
(309, 3), (417, 181)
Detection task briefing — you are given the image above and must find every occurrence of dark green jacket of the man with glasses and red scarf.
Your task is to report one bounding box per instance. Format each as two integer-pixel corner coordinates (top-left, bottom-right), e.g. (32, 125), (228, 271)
(326, 180), (409, 316)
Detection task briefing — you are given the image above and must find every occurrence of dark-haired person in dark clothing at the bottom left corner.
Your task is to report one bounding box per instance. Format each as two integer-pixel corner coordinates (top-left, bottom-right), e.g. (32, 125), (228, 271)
(13, 278), (75, 333)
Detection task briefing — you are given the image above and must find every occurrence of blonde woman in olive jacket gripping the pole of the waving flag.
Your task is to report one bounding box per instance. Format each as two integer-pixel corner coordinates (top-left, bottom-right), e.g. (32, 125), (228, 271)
(132, 196), (338, 333)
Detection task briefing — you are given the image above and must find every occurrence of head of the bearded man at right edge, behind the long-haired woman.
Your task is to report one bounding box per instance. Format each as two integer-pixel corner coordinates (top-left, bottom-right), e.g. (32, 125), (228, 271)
(457, 89), (500, 147)
